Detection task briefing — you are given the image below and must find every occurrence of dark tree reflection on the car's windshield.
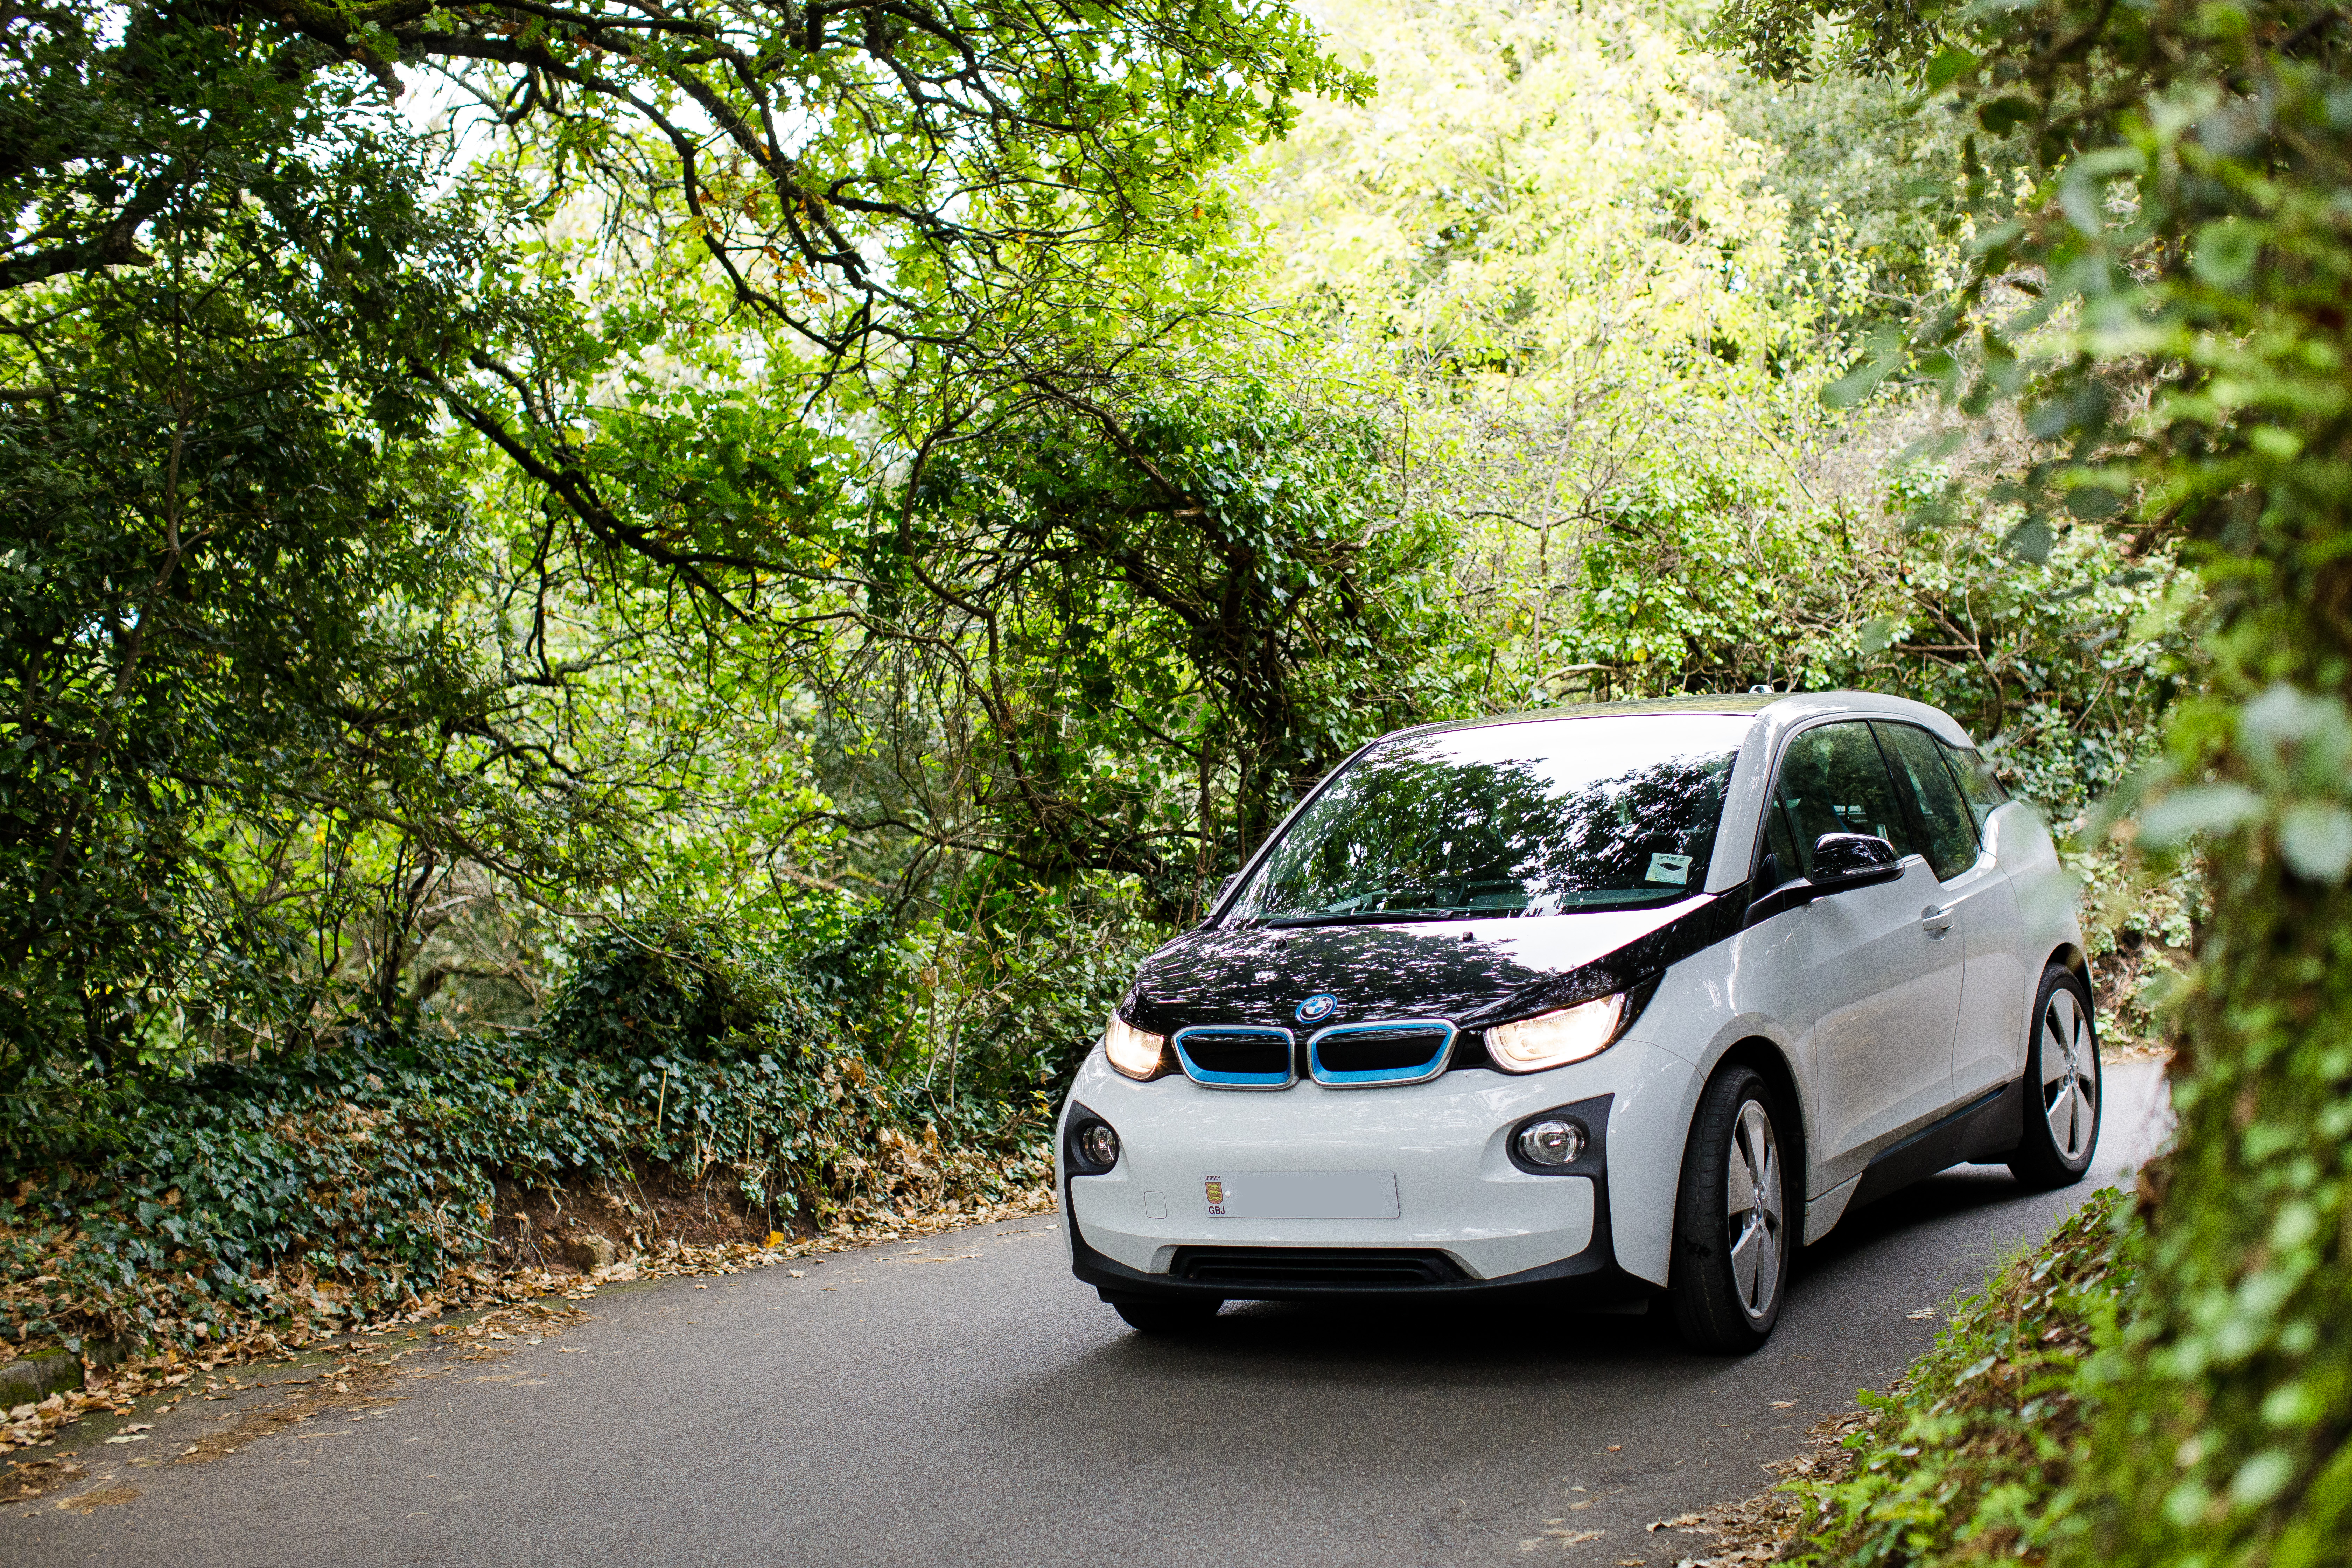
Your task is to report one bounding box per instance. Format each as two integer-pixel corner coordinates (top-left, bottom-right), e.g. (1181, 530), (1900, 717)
(1270, 741), (1731, 910)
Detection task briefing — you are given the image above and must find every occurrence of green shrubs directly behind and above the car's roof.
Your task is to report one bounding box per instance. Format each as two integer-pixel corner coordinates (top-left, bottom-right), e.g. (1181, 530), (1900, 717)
(1548, 465), (2194, 818)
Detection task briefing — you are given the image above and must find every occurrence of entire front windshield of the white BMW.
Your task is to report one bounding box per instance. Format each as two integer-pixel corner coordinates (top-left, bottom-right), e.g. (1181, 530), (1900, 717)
(1232, 715), (1750, 926)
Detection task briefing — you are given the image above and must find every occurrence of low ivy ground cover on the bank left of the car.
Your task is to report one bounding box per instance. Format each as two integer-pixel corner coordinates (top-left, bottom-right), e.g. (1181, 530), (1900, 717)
(0, 922), (1051, 1345)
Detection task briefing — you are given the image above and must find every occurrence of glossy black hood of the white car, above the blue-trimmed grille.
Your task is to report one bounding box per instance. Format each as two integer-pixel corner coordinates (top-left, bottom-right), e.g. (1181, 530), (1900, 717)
(1120, 889), (1748, 1034)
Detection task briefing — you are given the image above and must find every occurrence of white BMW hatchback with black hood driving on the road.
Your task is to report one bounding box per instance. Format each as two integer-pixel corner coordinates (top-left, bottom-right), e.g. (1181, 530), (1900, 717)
(1056, 691), (2103, 1352)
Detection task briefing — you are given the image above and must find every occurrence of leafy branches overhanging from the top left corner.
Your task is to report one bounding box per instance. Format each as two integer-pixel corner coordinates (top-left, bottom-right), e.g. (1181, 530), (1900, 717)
(0, 0), (1369, 588)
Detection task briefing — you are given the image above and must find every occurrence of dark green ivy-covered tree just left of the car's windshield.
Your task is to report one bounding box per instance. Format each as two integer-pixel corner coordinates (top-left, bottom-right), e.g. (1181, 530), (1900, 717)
(877, 381), (1463, 919)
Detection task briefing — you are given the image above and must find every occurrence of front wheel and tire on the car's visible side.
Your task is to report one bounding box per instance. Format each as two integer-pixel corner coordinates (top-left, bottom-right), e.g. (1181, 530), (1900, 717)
(1665, 1067), (1794, 1354)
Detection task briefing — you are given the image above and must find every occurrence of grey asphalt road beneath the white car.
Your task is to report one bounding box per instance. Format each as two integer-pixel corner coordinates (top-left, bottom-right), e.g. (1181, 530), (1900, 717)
(0, 1063), (2162, 1568)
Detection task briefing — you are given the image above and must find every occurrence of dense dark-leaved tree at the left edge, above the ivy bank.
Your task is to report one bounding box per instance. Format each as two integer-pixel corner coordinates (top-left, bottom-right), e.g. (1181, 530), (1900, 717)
(0, 101), (621, 1086)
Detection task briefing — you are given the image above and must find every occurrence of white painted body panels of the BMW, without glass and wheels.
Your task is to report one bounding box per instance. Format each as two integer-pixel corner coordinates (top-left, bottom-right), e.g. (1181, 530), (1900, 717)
(1056, 691), (2096, 1335)
